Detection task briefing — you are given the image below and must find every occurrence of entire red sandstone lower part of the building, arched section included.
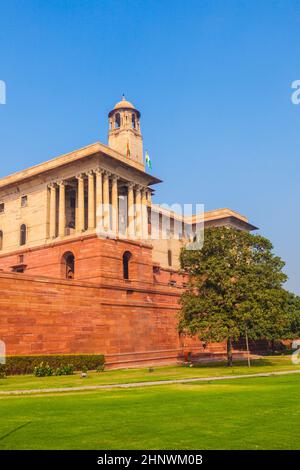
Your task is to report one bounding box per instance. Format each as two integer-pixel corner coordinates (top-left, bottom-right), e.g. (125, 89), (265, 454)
(0, 236), (248, 366)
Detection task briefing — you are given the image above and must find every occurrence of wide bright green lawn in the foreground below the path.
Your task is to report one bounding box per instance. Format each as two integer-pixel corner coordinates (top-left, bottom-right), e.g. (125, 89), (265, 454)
(0, 371), (300, 450)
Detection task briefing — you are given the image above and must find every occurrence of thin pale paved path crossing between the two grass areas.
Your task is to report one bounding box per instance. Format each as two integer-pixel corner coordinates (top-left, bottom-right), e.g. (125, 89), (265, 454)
(0, 370), (300, 397)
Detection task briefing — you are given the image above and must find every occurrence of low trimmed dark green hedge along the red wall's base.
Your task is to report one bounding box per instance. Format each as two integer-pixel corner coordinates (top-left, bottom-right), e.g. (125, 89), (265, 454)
(4, 354), (105, 375)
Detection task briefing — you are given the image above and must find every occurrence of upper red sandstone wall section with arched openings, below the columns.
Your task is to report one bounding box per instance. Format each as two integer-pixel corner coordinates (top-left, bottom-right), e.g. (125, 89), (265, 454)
(0, 235), (153, 283)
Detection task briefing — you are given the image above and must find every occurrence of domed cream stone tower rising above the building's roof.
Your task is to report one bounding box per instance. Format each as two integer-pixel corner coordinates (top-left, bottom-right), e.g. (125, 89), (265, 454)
(108, 95), (143, 165)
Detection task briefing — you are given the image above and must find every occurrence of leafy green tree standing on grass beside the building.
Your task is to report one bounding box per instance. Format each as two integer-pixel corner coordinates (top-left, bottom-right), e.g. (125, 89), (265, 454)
(179, 227), (300, 366)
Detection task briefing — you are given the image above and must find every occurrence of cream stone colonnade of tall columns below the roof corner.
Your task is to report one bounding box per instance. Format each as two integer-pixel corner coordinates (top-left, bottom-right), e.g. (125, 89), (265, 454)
(49, 168), (151, 239)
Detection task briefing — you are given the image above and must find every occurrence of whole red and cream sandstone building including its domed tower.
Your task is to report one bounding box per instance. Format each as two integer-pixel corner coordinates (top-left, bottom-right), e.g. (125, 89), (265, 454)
(0, 97), (255, 366)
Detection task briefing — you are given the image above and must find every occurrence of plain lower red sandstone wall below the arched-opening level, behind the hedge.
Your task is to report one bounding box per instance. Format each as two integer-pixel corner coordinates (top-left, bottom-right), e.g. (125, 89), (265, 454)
(0, 273), (185, 365)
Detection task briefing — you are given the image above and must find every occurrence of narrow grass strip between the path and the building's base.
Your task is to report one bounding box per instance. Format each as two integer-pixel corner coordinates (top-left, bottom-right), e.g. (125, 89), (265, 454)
(0, 356), (300, 393)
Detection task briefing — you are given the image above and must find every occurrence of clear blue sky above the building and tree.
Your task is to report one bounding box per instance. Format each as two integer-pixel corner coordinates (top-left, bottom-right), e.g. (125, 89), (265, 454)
(0, 0), (300, 294)
